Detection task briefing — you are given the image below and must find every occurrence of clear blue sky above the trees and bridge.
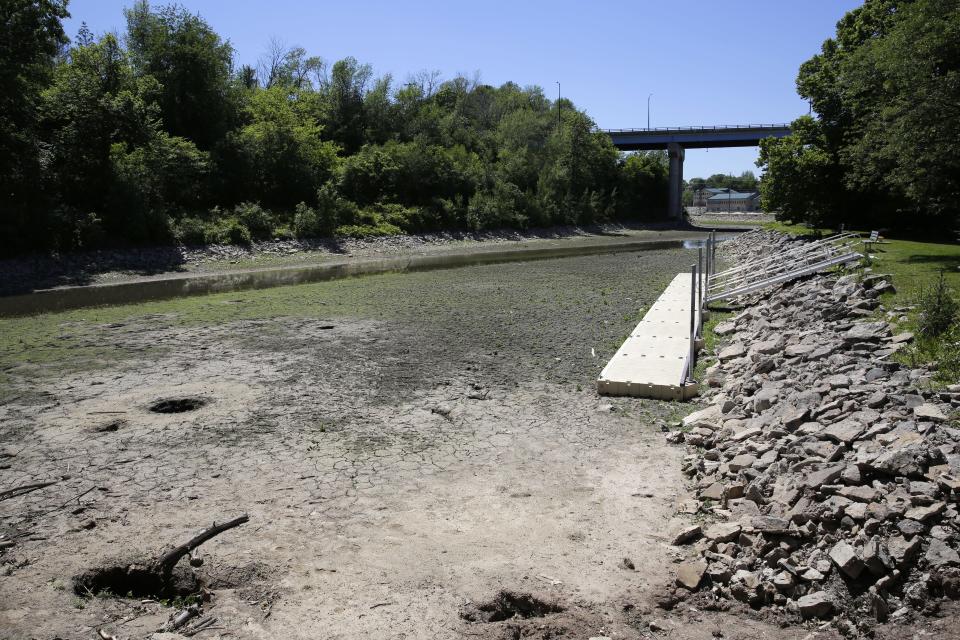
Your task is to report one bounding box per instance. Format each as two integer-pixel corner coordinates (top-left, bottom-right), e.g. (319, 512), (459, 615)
(66, 0), (861, 178)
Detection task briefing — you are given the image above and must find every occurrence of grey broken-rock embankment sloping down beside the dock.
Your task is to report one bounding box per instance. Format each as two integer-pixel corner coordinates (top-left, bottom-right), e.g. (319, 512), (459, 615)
(668, 232), (960, 634)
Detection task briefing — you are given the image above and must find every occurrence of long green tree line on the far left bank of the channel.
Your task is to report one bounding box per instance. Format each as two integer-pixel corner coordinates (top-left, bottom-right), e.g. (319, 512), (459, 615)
(0, 0), (668, 254)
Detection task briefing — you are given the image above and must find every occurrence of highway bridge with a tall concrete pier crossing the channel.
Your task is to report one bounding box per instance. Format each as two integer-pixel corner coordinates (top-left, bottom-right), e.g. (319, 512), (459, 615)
(602, 124), (790, 218)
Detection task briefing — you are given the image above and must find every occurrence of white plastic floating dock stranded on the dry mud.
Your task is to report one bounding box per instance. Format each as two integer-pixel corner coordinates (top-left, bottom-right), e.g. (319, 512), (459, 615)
(597, 273), (699, 400)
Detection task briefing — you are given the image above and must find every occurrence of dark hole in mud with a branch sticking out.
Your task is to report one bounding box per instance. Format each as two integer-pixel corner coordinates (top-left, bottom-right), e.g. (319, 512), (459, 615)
(73, 564), (202, 598)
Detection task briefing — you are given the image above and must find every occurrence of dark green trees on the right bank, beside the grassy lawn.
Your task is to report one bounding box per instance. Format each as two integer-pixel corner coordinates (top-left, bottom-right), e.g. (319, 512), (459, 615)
(757, 0), (960, 232)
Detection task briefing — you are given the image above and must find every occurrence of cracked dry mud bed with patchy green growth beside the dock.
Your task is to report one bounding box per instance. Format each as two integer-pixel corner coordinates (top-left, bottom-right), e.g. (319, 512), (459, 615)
(0, 250), (916, 639)
